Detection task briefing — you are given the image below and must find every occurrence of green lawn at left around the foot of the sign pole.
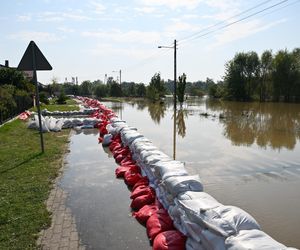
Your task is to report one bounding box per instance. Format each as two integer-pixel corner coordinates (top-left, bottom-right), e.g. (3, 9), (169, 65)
(0, 120), (70, 249)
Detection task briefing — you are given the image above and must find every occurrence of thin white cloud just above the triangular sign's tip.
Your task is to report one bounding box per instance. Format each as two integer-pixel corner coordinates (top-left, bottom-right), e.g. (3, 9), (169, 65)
(8, 31), (62, 42)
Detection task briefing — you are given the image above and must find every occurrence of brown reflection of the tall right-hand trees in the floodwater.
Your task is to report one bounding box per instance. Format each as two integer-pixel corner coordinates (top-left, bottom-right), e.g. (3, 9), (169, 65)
(206, 101), (300, 150)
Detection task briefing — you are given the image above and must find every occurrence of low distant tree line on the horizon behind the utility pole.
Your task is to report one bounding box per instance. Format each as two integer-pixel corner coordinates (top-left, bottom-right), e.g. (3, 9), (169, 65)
(41, 73), (215, 101)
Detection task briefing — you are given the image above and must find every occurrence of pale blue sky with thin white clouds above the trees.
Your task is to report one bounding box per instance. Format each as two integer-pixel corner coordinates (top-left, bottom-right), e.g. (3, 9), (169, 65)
(0, 0), (300, 84)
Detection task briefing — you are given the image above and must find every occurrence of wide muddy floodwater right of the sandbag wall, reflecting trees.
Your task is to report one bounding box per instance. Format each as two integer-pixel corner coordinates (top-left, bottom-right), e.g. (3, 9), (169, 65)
(105, 99), (300, 248)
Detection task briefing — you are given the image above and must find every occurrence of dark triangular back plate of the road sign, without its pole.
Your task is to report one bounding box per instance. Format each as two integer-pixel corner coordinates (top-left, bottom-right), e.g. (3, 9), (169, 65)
(18, 41), (52, 70)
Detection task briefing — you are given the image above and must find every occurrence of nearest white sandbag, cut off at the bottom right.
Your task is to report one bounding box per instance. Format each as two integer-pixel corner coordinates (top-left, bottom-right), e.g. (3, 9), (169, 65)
(225, 229), (288, 250)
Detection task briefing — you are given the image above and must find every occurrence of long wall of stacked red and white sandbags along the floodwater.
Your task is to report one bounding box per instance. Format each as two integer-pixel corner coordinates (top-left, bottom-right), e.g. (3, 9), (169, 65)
(81, 98), (295, 250)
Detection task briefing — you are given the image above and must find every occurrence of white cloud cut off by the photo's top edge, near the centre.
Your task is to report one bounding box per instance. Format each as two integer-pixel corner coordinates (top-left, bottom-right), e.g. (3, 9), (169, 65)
(138, 0), (201, 9)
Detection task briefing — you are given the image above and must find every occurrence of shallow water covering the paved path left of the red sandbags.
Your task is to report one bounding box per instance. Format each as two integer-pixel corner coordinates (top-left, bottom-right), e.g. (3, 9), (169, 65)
(59, 129), (152, 250)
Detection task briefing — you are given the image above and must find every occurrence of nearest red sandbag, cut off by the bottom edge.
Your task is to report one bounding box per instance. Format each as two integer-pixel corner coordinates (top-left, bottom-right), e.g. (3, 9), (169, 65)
(153, 230), (186, 250)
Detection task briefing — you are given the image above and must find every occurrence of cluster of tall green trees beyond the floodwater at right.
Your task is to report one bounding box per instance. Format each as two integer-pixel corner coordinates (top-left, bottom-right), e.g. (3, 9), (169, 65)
(209, 48), (300, 102)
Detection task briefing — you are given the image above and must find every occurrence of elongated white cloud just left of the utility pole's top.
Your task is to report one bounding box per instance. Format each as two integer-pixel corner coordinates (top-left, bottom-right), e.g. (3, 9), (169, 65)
(81, 30), (161, 44)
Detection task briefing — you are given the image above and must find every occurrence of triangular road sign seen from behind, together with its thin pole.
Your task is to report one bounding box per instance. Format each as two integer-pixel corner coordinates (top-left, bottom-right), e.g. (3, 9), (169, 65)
(18, 41), (52, 153)
